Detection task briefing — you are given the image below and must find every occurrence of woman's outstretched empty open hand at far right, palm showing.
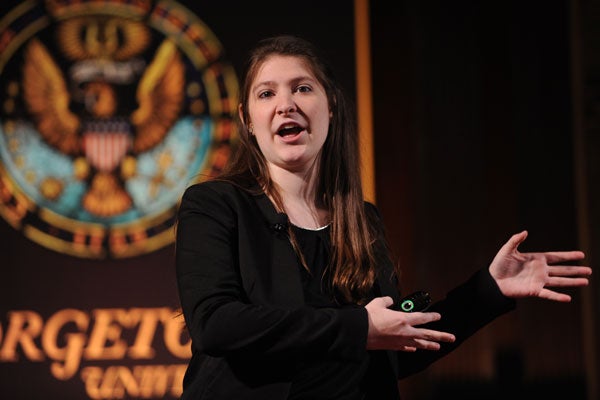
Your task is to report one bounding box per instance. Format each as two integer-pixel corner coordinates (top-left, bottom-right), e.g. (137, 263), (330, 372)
(489, 231), (592, 302)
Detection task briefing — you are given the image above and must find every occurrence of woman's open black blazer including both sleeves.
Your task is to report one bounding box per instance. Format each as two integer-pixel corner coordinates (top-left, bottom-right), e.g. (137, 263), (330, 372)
(176, 181), (514, 400)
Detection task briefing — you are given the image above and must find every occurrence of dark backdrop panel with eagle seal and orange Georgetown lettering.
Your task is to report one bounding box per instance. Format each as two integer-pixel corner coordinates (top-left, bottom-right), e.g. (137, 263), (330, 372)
(0, 0), (355, 399)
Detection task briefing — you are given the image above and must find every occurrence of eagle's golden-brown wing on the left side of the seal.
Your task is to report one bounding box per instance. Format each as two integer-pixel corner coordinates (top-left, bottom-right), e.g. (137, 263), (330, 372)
(23, 39), (80, 154)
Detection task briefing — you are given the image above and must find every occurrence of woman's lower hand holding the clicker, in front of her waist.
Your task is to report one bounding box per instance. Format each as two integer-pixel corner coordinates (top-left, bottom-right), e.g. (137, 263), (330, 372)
(365, 296), (456, 351)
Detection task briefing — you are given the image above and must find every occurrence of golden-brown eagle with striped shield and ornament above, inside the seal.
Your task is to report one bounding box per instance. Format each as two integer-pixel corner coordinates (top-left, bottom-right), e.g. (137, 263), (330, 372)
(22, 19), (185, 217)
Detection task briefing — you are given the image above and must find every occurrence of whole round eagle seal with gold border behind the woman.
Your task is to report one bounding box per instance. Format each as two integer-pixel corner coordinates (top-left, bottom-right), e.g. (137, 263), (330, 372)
(0, 0), (238, 258)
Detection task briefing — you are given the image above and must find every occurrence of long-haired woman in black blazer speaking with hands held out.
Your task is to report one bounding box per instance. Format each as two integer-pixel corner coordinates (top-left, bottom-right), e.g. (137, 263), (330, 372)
(177, 36), (591, 400)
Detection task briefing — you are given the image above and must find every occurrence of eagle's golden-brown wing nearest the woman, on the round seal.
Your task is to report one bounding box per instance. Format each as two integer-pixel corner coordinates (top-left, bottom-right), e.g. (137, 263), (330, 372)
(131, 40), (185, 153)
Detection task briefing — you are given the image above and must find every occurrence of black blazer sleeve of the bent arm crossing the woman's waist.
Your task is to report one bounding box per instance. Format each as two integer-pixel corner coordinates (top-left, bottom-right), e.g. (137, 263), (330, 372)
(176, 184), (368, 363)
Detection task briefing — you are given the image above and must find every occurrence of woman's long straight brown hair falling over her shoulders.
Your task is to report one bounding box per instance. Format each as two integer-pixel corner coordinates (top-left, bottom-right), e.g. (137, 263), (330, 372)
(220, 35), (376, 303)
